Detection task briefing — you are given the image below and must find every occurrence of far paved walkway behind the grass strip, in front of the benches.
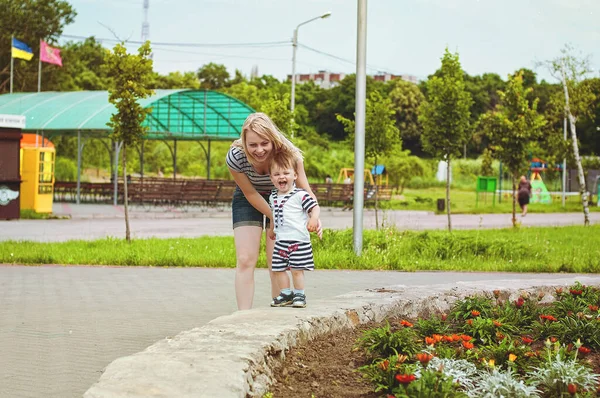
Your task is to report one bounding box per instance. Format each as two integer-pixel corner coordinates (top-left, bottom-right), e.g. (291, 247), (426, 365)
(0, 203), (600, 242)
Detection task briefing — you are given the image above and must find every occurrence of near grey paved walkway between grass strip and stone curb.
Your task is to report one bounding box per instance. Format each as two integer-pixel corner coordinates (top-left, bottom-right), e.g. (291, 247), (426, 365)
(0, 266), (592, 398)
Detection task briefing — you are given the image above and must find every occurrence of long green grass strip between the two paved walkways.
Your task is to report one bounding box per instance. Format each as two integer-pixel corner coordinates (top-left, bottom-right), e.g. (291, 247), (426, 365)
(0, 225), (600, 273)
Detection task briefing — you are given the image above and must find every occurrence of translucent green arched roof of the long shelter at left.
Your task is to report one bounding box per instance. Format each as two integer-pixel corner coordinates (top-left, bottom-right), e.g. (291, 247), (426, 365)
(0, 89), (254, 140)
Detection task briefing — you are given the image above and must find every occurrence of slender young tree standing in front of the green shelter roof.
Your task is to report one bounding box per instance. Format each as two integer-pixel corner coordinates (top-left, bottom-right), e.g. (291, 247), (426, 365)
(106, 41), (152, 242)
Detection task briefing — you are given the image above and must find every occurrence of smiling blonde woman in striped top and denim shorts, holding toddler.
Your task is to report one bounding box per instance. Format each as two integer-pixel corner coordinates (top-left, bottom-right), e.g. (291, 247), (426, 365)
(226, 113), (322, 310)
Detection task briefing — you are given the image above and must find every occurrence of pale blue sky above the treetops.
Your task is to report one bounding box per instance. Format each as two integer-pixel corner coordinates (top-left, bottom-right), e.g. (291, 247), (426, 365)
(60, 0), (600, 81)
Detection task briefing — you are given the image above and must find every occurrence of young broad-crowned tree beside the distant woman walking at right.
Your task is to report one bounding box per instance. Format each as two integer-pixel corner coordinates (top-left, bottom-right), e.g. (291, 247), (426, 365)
(481, 72), (546, 226)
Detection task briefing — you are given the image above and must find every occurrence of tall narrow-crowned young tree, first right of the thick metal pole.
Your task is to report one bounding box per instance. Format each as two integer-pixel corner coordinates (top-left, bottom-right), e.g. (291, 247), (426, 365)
(419, 48), (473, 231)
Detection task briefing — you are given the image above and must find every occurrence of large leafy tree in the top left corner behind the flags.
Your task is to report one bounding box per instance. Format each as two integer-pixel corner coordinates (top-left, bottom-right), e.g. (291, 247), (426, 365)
(0, 0), (77, 93)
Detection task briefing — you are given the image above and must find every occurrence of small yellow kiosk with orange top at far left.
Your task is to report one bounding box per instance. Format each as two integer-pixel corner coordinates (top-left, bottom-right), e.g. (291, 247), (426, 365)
(21, 134), (56, 213)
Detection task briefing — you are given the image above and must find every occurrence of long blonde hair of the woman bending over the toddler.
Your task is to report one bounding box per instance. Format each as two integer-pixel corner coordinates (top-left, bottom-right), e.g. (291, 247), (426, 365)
(231, 112), (302, 166)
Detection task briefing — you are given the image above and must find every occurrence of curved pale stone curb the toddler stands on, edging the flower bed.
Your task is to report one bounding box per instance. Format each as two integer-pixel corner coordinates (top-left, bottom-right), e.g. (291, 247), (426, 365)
(84, 276), (600, 398)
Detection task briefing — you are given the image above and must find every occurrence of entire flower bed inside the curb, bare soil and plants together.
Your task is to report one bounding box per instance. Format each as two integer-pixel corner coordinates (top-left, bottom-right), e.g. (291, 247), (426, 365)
(266, 283), (600, 398)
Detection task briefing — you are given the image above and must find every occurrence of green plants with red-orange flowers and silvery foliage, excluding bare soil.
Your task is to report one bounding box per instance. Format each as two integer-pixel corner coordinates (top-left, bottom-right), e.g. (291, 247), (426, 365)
(358, 283), (600, 398)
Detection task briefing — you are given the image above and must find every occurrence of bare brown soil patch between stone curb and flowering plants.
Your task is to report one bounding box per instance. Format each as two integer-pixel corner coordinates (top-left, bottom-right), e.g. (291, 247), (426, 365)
(270, 324), (380, 398)
